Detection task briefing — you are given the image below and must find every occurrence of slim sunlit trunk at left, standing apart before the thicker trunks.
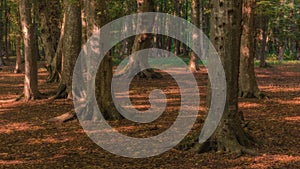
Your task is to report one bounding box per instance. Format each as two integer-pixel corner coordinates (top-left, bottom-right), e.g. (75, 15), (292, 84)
(19, 0), (40, 101)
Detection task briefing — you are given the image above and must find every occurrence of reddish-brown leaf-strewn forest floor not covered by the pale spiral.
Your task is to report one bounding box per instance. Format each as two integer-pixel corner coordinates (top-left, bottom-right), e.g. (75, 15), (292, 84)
(0, 60), (300, 169)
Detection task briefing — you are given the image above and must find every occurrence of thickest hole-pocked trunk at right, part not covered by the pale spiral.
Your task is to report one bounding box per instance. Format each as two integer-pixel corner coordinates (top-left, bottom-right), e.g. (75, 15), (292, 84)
(193, 0), (251, 154)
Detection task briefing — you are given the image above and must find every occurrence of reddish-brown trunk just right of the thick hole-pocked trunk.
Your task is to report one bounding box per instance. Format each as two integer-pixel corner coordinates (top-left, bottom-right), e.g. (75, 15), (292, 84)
(239, 0), (263, 98)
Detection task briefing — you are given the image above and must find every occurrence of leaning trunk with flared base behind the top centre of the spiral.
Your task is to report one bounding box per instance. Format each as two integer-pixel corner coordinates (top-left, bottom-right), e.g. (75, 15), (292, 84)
(116, 0), (161, 78)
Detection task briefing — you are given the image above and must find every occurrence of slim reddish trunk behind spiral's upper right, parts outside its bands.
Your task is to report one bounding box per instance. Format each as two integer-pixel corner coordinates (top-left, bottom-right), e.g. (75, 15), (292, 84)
(189, 0), (200, 72)
